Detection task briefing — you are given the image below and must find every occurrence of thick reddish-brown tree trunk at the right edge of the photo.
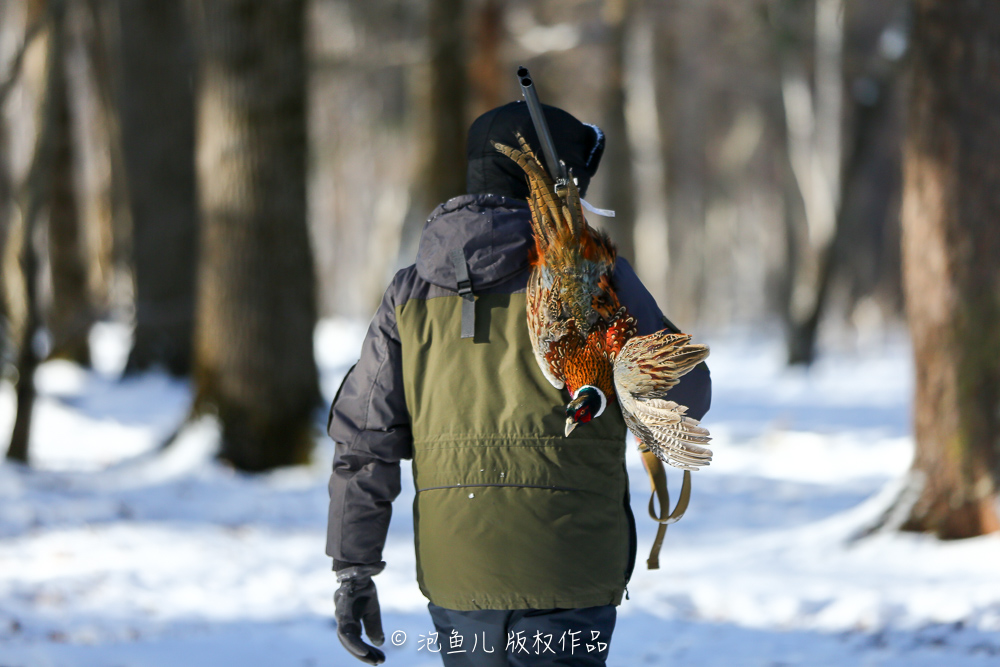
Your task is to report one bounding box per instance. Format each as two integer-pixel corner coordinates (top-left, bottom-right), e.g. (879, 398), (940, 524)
(903, 0), (1000, 539)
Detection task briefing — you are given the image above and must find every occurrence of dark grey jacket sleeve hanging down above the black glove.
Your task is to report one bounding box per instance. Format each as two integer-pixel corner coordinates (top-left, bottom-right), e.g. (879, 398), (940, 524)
(326, 281), (413, 570)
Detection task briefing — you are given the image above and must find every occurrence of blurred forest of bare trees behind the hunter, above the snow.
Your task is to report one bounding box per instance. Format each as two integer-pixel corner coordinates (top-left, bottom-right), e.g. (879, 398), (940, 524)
(0, 0), (997, 536)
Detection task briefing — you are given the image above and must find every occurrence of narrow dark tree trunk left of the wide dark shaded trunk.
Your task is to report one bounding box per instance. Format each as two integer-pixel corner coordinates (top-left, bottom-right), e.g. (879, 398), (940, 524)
(47, 0), (95, 365)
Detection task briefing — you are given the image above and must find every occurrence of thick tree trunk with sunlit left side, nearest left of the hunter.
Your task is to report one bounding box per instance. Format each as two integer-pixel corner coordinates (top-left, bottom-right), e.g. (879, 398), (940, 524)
(194, 0), (319, 470)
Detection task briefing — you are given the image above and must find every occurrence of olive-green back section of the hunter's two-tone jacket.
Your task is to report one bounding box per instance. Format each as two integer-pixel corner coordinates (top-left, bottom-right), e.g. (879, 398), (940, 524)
(396, 293), (634, 610)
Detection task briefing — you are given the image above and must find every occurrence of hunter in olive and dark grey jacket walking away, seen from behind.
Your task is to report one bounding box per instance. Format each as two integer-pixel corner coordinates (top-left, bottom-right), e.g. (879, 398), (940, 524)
(327, 102), (711, 667)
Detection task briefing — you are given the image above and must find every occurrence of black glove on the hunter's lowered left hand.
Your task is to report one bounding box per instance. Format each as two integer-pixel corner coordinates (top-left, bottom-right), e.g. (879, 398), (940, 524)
(333, 563), (385, 665)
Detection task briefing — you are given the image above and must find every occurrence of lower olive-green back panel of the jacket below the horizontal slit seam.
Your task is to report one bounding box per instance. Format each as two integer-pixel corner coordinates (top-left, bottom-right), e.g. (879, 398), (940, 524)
(414, 484), (631, 609)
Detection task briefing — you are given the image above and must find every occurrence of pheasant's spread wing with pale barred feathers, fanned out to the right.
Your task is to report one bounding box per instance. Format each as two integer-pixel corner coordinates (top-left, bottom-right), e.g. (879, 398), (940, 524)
(614, 331), (712, 470)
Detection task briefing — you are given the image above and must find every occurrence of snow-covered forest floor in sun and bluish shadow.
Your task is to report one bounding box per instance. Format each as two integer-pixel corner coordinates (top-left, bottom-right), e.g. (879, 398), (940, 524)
(0, 322), (1000, 667)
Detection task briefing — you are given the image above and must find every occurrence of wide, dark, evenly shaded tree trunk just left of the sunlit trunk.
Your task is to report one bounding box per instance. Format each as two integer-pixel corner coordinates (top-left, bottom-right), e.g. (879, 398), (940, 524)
(119, 0), (198, 375)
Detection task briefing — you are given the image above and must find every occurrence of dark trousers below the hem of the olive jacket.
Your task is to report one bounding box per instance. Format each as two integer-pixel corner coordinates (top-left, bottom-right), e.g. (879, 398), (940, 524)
(427, 603), (617, 667)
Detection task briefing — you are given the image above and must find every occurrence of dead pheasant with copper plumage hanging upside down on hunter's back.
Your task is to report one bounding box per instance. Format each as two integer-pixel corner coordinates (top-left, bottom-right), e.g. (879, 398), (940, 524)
(493, 135), (712, 470)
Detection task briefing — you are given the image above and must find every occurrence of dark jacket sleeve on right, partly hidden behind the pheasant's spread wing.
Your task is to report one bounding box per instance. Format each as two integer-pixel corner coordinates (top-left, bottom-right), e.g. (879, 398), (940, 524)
(615, 257), (712, 419)
